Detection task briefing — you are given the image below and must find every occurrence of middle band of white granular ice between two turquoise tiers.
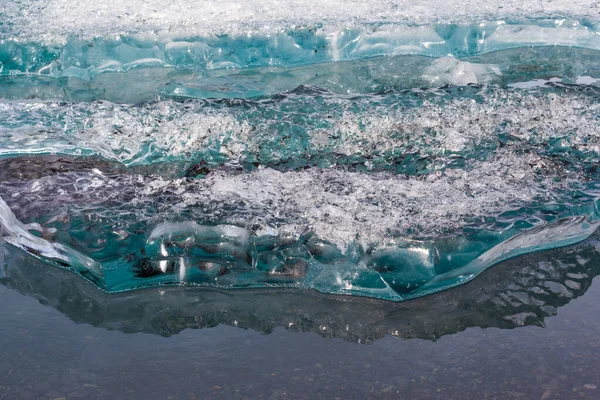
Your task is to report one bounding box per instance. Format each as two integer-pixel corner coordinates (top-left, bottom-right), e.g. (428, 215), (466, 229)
(0, 91), (600, 165)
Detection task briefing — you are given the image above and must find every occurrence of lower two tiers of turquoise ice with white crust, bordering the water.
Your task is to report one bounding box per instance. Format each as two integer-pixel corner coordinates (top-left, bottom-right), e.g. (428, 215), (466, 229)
(0, 83), (598, 300)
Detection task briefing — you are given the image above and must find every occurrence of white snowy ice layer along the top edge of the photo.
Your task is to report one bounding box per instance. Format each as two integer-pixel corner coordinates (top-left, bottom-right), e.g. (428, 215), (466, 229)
(1, 0), (600, 39)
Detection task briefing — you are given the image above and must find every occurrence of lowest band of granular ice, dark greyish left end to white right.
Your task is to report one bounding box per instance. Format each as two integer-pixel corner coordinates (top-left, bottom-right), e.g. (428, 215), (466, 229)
(2, 150), (577, 249)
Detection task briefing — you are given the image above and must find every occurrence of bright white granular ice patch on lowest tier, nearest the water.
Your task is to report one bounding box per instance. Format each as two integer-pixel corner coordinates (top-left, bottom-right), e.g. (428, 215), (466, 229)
(151, 153), (564, 249)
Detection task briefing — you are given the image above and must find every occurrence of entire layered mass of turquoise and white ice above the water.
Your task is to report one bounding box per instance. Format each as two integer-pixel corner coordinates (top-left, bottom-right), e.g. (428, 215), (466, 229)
(0, 0), (600, 300)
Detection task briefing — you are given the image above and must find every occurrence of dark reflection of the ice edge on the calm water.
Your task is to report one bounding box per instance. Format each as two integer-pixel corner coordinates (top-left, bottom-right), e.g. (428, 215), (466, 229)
(0, 234), (600, 343)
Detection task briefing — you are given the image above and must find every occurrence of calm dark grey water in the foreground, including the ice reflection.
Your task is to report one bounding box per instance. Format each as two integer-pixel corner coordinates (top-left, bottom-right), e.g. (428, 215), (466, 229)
(0, 237), (600, 399)
